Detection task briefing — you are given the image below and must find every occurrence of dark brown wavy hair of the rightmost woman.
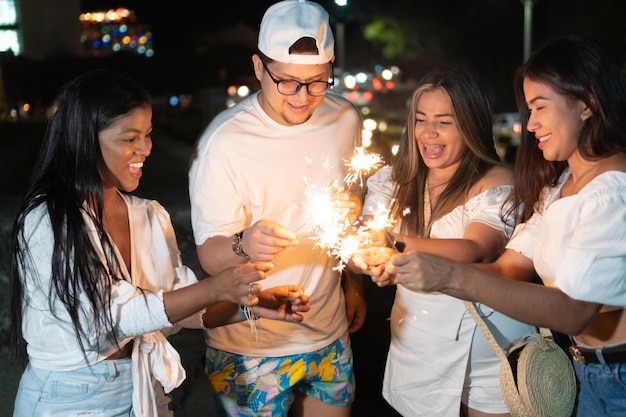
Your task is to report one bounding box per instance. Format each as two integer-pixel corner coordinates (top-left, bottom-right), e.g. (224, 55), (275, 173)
(509, 35), (626, 223)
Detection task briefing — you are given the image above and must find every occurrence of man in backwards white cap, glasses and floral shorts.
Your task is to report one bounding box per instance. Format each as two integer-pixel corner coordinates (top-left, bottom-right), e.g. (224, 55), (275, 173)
(189, 0), (366, 417)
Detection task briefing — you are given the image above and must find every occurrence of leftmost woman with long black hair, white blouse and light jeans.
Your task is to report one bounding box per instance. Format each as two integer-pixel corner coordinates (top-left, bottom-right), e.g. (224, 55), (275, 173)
(11, 70), (308, 417)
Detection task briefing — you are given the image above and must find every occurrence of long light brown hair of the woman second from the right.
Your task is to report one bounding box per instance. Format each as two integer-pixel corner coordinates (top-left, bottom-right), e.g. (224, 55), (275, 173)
(391, 67), (502, 237)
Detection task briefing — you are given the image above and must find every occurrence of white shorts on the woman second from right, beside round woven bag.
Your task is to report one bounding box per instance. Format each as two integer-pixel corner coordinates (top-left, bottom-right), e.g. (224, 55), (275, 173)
(383, 300), (534, 417)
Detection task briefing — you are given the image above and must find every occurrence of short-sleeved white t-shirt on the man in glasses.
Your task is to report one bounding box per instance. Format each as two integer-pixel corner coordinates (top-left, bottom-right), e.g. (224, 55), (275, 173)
(189, 93), (362, 356)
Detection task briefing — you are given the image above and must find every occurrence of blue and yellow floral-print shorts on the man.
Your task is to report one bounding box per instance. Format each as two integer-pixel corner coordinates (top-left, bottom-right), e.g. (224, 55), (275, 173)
(206, 334), (354, 417)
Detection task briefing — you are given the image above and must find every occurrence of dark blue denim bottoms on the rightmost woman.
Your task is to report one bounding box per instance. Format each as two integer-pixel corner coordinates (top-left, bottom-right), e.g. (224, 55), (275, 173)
(574, 361), (626, 417)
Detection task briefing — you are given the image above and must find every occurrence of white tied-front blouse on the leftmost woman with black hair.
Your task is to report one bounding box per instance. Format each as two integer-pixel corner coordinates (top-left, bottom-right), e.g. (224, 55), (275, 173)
(22, 195), (202, 415)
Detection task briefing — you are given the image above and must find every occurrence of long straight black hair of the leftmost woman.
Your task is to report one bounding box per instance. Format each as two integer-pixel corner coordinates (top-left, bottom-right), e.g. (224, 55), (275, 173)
(10, 70), (151, 362)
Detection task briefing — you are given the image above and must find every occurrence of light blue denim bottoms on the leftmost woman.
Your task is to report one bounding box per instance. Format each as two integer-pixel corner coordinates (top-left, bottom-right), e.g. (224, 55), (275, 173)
(13, 358), (134, 417)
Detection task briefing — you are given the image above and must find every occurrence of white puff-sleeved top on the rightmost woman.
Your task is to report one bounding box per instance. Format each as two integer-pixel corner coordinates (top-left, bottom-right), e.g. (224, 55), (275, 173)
(507, 169), (626, 307)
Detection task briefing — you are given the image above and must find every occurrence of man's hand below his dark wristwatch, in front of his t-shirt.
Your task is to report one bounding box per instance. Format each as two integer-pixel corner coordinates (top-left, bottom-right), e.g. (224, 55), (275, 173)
(242, 220), (297, 262)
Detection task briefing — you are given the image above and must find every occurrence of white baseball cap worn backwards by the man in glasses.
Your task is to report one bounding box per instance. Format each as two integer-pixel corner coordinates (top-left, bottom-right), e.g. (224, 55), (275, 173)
(258, 0), (335, 64)
